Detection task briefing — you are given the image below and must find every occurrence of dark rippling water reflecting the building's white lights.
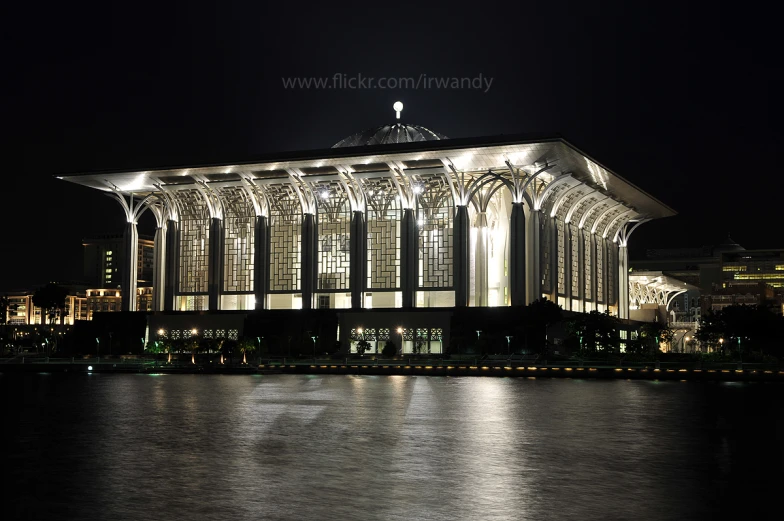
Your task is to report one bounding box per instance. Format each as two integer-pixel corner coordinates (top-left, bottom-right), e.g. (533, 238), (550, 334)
(0, 374), (784, 520)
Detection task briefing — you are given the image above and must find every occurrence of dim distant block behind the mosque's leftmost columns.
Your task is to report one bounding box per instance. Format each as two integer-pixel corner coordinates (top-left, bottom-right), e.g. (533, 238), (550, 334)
(82, 233), (155, 288)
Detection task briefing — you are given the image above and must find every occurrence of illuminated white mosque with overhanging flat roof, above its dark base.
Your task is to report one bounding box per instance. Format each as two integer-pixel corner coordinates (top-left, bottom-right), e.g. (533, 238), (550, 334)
(64, 128), (674, 318)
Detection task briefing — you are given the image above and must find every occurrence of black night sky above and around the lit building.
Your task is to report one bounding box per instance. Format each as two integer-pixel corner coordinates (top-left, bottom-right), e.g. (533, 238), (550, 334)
(0, 2), (784, 291)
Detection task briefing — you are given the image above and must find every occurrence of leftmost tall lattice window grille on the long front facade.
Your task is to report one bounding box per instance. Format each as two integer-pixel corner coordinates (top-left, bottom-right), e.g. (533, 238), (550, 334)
(175, 189), (210, 293)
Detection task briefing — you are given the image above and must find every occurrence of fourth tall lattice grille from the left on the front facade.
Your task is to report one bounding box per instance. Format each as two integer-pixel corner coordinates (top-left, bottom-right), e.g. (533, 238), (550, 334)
(314, 183), (351, 290)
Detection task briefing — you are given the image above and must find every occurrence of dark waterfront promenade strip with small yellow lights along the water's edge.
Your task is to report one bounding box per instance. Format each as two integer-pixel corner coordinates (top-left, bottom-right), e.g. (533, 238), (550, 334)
(0, 355), (784, 382)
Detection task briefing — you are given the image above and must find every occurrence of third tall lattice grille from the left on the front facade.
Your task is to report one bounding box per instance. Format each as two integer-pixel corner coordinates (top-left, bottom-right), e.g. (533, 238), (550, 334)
(272, 185), (302, 293)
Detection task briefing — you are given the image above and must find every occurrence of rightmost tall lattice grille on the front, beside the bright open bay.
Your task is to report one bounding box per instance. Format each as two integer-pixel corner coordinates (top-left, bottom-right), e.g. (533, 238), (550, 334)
(416, 176), (454, 288)
